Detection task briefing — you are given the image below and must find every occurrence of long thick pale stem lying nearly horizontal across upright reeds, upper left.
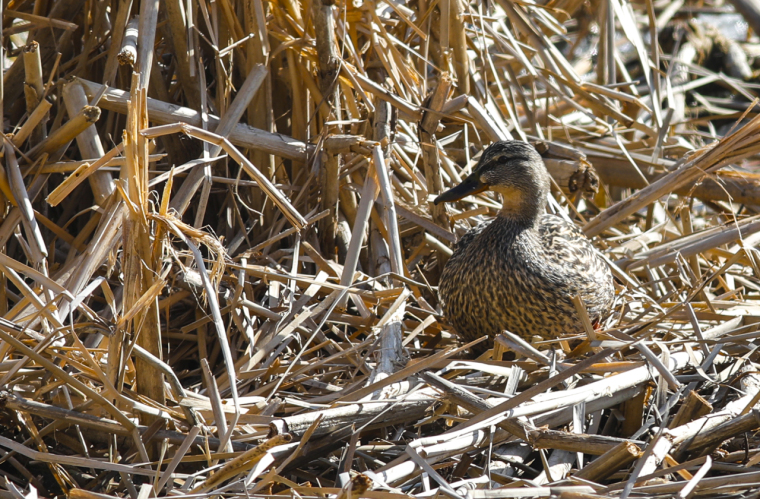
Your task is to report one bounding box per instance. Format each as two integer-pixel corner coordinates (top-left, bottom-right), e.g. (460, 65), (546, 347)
(78, 79), (308, 161)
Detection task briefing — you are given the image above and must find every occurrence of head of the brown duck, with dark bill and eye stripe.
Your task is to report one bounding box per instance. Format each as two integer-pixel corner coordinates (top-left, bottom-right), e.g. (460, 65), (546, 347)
(435, 140), (550, 225)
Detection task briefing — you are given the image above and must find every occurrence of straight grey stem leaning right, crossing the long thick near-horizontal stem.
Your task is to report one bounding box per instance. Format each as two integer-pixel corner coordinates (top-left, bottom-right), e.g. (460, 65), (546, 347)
(171, 65), (267, 214)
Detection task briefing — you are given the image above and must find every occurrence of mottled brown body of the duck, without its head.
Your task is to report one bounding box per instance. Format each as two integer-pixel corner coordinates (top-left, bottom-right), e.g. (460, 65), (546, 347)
(439, 215), (614, 340)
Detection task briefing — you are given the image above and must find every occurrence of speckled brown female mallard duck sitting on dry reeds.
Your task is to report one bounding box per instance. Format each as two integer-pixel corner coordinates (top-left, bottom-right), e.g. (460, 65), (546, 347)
(435, 141), (615, 341)
